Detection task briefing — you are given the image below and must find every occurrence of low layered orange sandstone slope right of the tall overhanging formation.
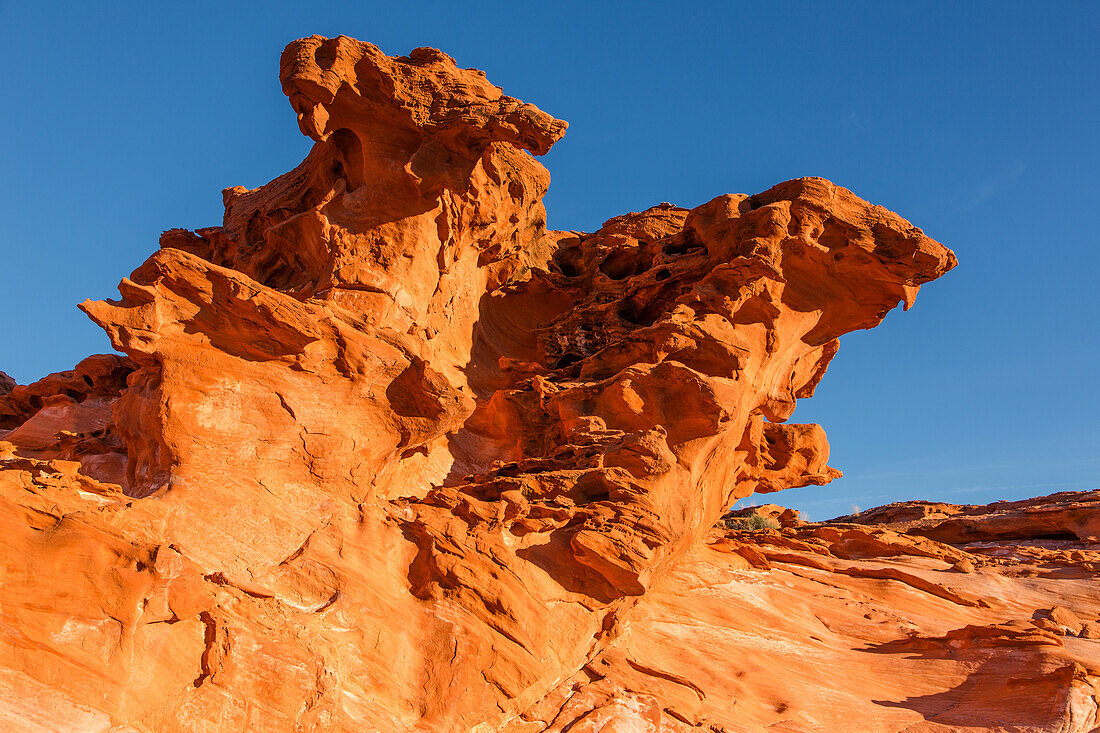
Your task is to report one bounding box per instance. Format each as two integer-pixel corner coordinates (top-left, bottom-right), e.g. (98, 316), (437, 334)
(539, 491), (1100, 733)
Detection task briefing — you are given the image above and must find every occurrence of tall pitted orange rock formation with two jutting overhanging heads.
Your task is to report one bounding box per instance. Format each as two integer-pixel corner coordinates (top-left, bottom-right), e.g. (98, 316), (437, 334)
(0, 36), (990, 731)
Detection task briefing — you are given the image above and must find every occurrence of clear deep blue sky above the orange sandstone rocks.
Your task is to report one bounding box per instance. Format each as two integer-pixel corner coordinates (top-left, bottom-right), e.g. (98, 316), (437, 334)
(0, 1), (1100, 518)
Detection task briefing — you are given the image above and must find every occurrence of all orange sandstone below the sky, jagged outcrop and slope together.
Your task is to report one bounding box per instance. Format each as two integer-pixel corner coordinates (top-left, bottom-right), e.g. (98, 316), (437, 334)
(0, 36), (1100, 732)
